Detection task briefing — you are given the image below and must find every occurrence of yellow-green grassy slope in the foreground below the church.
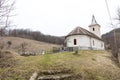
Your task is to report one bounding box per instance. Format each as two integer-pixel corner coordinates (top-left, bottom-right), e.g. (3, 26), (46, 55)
(0, 51), (120, 80)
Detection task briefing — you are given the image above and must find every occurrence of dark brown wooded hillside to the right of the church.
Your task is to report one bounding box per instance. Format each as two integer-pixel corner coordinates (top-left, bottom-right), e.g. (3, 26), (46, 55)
(102, 28), (120, 63)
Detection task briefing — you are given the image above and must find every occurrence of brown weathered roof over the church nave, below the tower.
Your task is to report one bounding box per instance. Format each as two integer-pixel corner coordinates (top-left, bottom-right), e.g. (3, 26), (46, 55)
(66, 26), (102, 40)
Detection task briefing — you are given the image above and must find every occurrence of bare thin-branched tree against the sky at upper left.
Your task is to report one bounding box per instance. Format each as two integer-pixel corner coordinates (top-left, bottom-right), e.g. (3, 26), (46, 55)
(0, 0), (15, 36)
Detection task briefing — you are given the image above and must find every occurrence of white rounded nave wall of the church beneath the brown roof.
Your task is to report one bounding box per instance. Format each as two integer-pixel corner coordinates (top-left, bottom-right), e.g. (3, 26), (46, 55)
(66, 35), (104, 50)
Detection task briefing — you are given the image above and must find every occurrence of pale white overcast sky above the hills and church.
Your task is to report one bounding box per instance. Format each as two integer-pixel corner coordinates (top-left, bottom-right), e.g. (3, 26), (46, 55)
(13, 0), (120, 36)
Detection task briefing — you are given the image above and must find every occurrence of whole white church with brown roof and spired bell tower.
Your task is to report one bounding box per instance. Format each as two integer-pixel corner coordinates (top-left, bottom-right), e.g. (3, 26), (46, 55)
(66, 15), (104, 50)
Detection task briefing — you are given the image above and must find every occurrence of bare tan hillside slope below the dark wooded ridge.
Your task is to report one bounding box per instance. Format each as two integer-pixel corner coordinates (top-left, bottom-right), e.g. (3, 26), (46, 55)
(0, 37), (59, 52)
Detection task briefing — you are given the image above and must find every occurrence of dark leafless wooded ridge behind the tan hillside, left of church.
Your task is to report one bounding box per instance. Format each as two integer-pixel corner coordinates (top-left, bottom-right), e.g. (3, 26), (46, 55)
(2, 29), (64, 45)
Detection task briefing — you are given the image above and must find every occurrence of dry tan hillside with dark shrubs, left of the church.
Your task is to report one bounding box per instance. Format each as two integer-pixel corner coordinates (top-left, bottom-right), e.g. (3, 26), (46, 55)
(0, 37), (59, 54)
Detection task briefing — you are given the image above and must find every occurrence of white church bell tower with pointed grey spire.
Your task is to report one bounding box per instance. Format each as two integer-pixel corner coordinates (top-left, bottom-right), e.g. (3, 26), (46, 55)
(89, 15), (101, 38)
